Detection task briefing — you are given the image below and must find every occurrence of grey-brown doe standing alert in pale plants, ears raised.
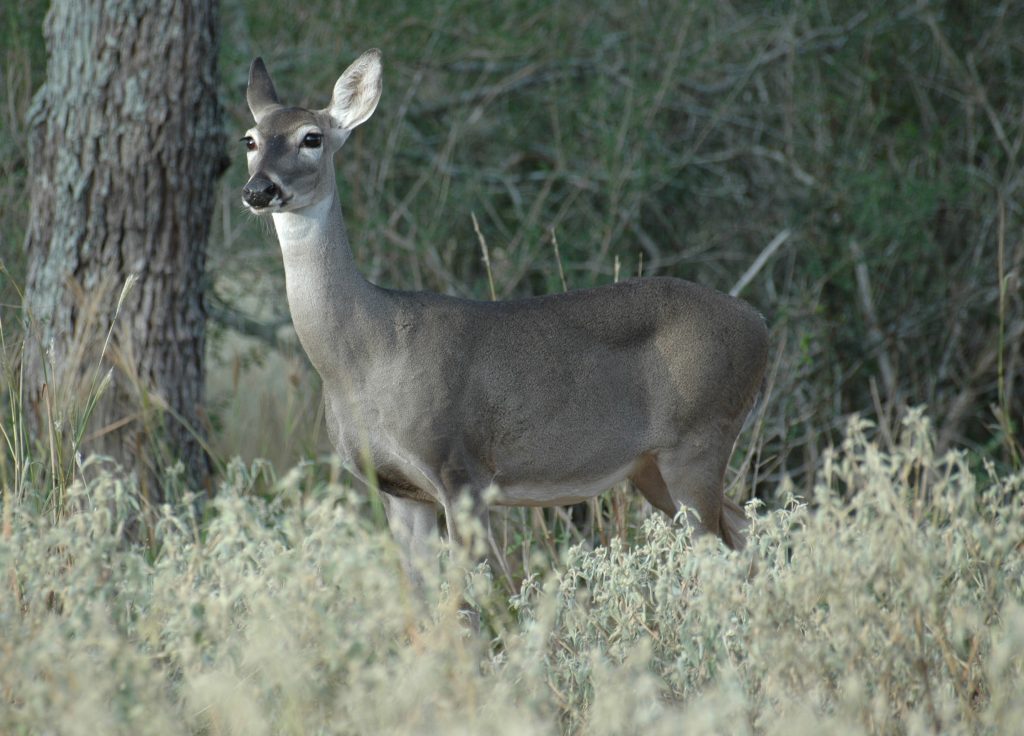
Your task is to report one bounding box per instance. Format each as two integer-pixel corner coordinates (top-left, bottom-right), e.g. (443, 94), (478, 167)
(242, 49), (768, 593)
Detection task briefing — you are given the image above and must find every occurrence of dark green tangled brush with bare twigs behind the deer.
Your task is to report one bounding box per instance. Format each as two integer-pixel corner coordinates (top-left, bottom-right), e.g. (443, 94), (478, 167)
(201, 0), (1024, 483)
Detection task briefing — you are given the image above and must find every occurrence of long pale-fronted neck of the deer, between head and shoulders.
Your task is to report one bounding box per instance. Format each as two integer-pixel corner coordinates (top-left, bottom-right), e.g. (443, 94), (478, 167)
(273, 193), (386, 381)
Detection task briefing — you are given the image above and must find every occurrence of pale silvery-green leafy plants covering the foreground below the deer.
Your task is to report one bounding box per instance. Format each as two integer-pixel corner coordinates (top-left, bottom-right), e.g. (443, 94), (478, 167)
(0, 413), (1024, 734)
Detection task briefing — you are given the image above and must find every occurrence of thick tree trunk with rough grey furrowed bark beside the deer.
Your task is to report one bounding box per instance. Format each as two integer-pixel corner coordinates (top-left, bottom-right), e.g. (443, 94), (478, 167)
(24, 0), (225, 501)
